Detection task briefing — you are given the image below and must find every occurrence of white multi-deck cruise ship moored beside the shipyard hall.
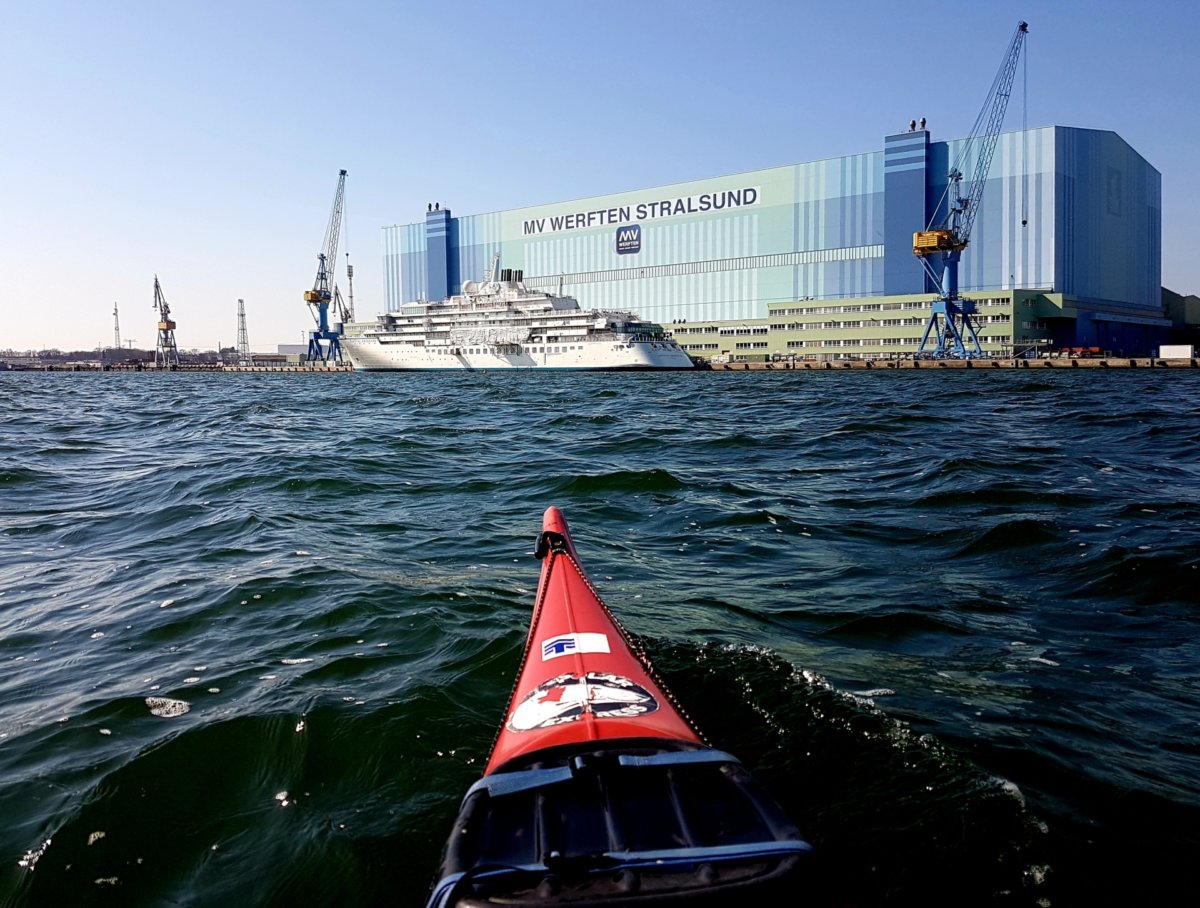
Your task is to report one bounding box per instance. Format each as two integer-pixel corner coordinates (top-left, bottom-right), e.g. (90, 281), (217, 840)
(341, 264), (692, 372)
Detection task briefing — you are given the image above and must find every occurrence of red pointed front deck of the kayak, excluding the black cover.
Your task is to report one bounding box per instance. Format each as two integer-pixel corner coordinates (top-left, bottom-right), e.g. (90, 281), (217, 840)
(485, 507), (703, 775)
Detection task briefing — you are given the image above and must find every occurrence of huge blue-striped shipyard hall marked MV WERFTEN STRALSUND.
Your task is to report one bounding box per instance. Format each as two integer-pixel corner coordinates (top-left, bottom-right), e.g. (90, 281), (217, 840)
(383, 126), (1170, 362)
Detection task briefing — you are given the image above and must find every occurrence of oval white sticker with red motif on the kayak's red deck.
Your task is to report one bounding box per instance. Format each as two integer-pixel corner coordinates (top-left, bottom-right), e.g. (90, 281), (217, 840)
(508, 672), (659, 732)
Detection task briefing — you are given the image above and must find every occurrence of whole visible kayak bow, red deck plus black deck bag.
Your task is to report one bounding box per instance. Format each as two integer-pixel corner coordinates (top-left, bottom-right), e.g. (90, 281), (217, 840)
(428, 507), (812, 908)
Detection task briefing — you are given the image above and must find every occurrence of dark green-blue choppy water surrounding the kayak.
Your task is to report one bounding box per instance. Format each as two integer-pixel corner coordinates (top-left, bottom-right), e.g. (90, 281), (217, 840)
(0, 369), (1200, 908)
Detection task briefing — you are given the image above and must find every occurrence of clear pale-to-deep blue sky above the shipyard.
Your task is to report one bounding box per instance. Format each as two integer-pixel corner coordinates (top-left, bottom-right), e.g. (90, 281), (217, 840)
(0, 0), (1200, 350)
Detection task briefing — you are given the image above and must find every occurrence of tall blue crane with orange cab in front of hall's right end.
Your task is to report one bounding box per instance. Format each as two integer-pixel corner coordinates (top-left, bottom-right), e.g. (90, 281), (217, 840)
(912, 22), (1030, 359)
